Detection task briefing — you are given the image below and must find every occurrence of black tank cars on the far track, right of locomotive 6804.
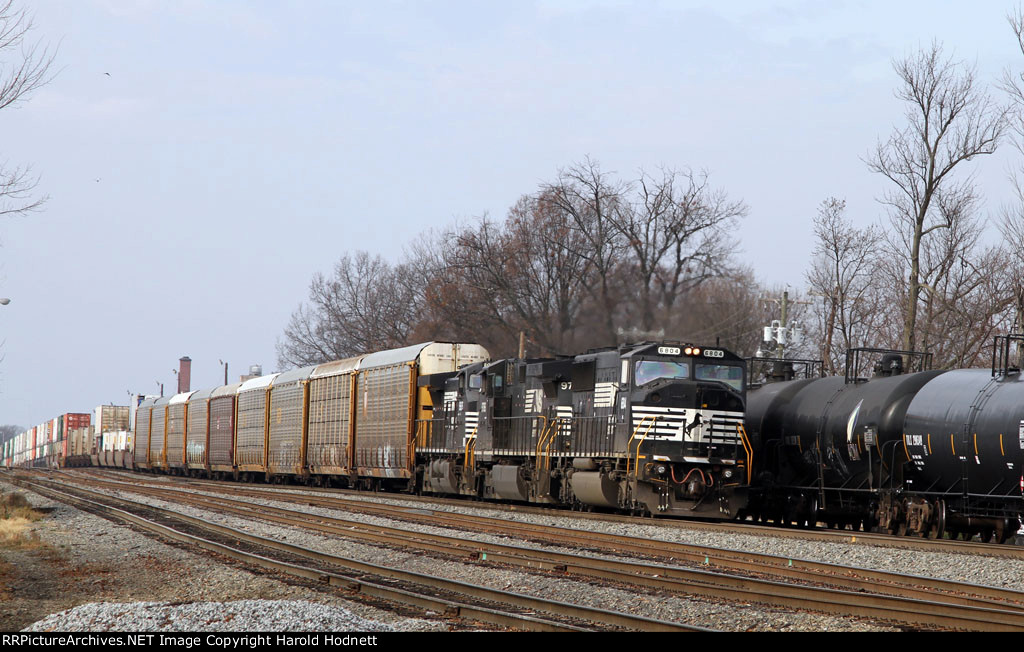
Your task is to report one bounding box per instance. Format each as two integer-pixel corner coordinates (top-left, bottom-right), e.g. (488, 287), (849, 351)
(745, 336), (1024, 542)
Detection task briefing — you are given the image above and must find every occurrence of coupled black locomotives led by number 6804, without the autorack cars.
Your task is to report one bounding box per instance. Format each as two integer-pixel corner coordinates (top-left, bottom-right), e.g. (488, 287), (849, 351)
(416, 343), (751, 519)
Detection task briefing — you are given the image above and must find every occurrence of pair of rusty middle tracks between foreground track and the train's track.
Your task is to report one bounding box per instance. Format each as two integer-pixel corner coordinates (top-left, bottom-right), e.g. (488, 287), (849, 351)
(18, 474), (1024, 631)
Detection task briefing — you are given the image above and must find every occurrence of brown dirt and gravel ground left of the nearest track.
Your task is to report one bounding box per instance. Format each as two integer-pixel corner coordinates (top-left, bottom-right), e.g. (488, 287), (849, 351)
(0, 479), (450, 632)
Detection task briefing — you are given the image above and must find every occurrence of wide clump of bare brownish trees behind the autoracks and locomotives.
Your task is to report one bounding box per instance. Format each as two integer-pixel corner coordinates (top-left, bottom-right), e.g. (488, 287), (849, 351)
(279, 160), (746, 365)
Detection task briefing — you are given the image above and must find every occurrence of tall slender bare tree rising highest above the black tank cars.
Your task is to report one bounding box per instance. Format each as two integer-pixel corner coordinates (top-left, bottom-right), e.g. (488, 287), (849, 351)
(867, 43), (1008, 349)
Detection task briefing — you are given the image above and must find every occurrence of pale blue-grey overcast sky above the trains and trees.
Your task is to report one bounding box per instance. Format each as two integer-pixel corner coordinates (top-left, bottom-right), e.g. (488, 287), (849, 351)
(0, 0), (1024, 427)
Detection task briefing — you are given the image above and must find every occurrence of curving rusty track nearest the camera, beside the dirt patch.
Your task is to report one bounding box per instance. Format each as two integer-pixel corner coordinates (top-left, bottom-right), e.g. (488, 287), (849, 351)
(10, 476), (709, 632)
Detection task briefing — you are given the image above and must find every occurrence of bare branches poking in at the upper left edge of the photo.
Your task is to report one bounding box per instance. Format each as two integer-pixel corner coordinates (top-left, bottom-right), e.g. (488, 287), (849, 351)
(0, 0), (53, 215)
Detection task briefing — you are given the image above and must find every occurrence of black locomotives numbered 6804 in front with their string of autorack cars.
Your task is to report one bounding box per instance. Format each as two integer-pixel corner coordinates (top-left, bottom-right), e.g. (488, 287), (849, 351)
(123, 342), (750, 518)
